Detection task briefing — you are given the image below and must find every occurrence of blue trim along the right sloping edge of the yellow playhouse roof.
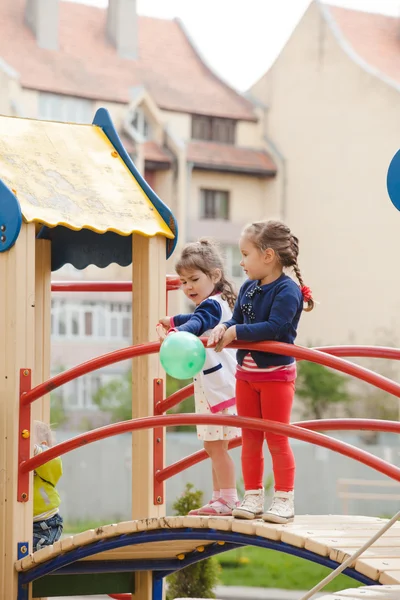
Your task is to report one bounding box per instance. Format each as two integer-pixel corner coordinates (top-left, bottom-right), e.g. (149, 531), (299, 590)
(93, 108), (178, 258)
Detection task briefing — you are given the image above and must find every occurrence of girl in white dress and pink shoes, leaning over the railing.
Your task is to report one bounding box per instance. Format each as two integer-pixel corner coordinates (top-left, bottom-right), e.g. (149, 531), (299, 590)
(157, 239), (240, 516)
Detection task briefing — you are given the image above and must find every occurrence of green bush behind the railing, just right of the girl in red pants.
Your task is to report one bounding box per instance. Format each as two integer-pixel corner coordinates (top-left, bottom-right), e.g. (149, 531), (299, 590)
(296, 361), (350, 419)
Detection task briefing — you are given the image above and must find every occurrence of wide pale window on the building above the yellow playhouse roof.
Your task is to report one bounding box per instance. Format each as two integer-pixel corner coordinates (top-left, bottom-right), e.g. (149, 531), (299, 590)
(39, 92), (94, 123)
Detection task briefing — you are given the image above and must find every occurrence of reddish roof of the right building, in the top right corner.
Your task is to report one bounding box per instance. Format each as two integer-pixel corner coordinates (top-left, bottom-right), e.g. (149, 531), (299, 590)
(327, 6), (400, 83)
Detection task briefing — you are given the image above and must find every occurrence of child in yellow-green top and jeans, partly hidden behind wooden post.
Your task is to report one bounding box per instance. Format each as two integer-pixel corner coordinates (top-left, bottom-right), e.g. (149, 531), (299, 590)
(33, 421), (63, 552)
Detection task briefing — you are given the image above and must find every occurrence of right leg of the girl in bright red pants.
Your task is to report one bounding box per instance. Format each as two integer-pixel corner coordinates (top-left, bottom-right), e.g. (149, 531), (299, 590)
(258, 381), (295, 492)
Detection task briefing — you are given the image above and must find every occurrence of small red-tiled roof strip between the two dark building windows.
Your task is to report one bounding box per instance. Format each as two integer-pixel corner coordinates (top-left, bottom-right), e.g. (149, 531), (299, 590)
(187, 141), (277, 176)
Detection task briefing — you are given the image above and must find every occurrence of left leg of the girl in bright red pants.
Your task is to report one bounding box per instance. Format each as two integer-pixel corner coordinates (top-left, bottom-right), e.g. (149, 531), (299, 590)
(236, 379), (264, 490)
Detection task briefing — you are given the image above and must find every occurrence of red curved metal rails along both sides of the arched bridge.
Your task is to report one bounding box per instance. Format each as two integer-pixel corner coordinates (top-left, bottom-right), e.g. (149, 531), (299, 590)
(19, 339), (400, 502)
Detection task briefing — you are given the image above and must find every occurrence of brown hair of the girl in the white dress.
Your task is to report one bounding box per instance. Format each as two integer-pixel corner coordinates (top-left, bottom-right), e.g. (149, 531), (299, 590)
(175, 238), (236, 309)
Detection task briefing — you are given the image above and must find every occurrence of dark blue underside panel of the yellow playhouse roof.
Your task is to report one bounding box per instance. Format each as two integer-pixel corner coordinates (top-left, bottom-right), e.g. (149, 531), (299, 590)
(37, 225), (132, 271)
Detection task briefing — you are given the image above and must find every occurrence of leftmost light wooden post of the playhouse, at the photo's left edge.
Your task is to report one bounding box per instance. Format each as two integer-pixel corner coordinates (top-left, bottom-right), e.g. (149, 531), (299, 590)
(0, 223), (35, 600)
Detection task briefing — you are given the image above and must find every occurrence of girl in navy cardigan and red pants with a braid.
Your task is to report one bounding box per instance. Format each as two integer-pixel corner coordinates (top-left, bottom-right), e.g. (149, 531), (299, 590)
(208, 221), (314, 523)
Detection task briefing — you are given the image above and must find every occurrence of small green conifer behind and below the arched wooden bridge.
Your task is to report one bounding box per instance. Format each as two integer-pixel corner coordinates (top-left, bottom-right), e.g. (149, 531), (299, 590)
(167, 483), (219, 600)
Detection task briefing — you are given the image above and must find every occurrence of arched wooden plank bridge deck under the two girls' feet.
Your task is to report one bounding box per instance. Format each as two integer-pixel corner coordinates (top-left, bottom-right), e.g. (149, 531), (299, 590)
(16, 515), (400, 584)
